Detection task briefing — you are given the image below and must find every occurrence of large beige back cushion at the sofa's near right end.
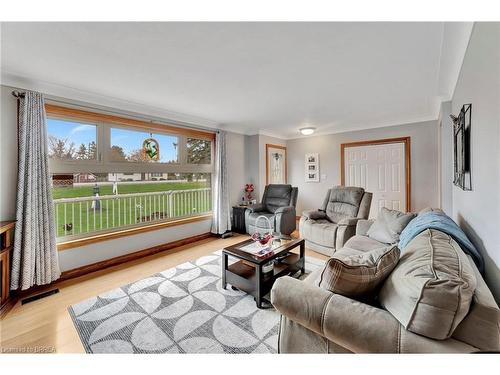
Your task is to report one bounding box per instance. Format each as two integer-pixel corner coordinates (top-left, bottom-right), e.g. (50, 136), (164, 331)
(379, 229), (476, 340)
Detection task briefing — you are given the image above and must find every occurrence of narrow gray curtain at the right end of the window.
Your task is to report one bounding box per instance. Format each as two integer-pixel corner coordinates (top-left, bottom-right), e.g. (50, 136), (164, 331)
(212, 131), (231, 234)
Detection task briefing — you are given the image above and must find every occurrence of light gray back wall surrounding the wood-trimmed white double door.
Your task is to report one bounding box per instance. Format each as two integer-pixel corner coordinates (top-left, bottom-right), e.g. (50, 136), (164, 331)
(287, 121), (439, 215)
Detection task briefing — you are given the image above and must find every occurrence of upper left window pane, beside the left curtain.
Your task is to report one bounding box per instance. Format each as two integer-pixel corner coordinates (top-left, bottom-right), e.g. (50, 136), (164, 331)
(47, 118), (97, 160)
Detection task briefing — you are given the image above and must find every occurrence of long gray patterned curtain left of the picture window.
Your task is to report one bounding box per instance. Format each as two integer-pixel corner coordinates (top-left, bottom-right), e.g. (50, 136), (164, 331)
(10, 92), (61, 290)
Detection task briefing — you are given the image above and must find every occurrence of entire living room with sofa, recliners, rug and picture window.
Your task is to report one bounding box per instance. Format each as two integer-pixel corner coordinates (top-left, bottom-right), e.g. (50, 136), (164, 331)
(0, 0), (500, 370)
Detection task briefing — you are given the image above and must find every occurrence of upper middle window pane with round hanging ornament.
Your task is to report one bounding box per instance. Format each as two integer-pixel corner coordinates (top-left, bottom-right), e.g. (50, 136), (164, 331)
(110, 128), (179, 163)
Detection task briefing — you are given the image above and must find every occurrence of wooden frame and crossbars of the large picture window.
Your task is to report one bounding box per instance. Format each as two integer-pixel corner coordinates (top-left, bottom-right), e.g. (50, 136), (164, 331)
(45, 104), (215, 251)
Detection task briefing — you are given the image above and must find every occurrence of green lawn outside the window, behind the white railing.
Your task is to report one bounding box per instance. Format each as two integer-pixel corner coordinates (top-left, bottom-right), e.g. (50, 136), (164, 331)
(53, 182), (211, 237)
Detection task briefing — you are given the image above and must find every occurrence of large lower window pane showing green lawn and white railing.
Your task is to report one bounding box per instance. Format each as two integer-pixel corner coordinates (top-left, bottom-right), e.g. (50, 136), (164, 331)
(52, 172), (212, 238)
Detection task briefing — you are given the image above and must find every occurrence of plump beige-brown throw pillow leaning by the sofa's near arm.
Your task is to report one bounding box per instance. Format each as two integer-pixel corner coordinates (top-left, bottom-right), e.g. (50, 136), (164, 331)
(319, 245), (399, 297)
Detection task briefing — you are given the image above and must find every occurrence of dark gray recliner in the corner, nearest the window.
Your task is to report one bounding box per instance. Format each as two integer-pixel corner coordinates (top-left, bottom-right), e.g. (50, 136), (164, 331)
(245, 184), (298, 236)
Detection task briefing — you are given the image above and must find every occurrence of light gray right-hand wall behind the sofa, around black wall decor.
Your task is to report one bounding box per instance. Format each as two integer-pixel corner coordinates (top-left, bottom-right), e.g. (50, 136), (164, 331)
(443, 23), (500, 302)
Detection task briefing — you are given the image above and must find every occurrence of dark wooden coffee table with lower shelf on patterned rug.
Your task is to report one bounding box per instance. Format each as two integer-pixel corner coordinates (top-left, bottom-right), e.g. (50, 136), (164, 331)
(222, 239), (305, 308)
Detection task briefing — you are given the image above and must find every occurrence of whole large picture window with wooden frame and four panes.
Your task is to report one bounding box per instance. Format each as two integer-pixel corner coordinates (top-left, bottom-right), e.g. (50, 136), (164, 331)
(47, 106), (214, 247)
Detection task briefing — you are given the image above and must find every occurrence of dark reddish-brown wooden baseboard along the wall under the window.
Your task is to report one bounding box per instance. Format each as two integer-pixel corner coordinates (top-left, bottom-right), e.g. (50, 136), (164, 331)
(58, 233), (213, 281)
